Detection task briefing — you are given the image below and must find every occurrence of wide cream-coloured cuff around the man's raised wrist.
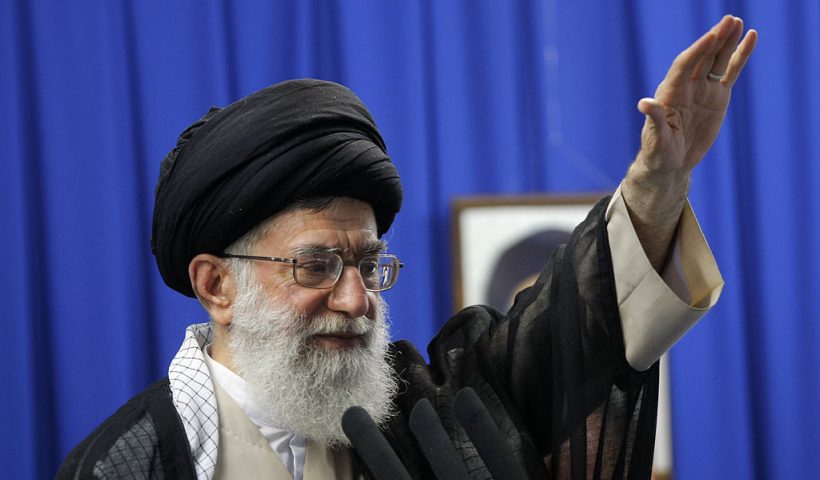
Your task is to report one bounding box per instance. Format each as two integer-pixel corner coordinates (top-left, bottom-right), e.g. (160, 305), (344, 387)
(606, 187), (723, 371)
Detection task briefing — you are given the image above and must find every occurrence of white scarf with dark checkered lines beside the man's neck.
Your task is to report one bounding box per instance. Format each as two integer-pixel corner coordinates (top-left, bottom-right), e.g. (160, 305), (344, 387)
(168, 323), (219, 480)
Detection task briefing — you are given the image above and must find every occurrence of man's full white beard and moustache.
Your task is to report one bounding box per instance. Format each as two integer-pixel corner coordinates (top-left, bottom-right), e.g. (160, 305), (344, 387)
(228, 282), (398, 447)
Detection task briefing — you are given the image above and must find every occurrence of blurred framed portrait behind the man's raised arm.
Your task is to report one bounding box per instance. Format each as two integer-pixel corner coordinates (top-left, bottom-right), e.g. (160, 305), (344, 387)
(452, 193), (673, 479)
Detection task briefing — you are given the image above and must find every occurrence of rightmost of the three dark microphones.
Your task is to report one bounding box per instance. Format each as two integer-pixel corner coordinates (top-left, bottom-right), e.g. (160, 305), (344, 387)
(453, 387), (527, 480)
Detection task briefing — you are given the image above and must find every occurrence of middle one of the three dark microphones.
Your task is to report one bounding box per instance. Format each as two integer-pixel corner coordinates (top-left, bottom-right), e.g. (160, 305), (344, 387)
(410, 398), (471, 480)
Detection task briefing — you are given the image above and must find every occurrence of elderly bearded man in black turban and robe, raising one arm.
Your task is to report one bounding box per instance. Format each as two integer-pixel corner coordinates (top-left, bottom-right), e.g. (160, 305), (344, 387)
(58, 16), (756, 479)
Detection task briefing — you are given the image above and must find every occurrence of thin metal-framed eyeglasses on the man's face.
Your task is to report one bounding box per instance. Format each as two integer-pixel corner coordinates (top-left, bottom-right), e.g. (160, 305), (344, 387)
(222, 252), (404, 292)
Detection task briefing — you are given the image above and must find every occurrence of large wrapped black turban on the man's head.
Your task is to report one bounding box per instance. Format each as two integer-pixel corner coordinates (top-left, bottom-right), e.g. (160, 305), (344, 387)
(151, 79), (402, 297)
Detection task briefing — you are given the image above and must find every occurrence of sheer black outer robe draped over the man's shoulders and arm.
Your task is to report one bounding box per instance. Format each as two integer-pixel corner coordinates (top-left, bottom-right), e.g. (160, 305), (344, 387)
(57, 198), (658, 479)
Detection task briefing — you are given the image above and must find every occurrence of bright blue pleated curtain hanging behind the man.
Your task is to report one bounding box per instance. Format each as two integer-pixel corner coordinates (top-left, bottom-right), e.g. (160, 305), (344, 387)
(0, 0), (820, 479)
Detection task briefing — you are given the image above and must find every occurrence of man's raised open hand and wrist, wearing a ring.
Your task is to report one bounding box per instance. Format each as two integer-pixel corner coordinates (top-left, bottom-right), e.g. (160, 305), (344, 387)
(621, 15), (757, 270)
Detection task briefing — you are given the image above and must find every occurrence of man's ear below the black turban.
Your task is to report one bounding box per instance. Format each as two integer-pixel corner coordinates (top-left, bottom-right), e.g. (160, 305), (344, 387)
(188, 253), (236, 327)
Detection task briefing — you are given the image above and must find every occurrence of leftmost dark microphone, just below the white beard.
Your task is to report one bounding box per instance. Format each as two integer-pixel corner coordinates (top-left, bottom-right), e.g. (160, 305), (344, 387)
(342, 405), (412, 480)
